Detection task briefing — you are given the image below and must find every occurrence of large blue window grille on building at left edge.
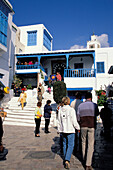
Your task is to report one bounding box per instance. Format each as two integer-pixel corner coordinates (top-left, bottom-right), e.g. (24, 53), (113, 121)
(0, 10), (8, 46)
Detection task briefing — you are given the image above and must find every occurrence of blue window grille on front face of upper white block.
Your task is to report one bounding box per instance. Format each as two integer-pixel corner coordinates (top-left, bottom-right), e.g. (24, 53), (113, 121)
(27, 31), (37, 46)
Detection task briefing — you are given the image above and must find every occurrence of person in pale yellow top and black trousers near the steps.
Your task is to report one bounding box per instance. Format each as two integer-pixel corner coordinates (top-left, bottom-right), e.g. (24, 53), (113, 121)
(35, 102), (42, 137)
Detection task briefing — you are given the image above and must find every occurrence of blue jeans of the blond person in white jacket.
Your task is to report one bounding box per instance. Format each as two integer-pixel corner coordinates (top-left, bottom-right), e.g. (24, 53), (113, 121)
(62, 133), (75, 161)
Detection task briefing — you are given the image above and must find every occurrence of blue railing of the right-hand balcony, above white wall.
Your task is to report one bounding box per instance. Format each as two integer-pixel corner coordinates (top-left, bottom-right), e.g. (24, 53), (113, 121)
(64, 68), (96, 77)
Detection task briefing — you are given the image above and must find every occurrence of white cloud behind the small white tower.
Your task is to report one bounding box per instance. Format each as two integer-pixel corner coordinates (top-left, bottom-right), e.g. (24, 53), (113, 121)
(96, 34), (109, 47)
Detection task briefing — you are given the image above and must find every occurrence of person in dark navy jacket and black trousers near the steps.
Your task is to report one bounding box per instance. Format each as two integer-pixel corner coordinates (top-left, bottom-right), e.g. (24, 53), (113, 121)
(44, 100), (52, 133)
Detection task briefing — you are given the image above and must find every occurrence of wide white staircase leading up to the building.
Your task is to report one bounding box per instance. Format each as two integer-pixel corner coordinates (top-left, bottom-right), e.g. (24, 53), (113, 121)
(4, 86), (57, 127)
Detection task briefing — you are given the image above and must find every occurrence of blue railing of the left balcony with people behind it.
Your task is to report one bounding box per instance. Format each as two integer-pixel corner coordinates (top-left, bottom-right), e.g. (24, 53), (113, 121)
(16, 64), (45, 72)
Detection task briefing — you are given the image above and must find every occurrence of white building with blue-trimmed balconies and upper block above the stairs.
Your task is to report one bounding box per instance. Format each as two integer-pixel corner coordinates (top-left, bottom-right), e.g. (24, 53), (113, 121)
(16, 24), (113, 102)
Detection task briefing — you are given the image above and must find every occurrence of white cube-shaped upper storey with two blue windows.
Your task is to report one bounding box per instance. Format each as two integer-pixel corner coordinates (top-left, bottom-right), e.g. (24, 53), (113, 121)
(19, 24), (53, 53)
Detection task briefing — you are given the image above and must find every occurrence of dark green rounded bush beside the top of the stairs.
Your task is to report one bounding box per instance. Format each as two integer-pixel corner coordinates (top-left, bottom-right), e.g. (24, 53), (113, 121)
(53, 81), (67, 104)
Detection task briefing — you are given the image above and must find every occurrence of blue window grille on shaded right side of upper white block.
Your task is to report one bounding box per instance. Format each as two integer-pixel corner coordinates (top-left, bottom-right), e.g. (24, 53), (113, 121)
(43, 29), (52, 51)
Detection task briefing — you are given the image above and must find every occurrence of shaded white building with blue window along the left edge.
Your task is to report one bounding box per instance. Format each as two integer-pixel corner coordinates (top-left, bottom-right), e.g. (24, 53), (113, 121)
(0, 0), (16, 87)
